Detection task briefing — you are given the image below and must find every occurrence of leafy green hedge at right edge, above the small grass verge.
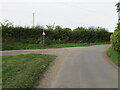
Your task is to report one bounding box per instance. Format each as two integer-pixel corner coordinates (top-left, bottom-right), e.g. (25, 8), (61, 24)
(111, 30), (120, 52)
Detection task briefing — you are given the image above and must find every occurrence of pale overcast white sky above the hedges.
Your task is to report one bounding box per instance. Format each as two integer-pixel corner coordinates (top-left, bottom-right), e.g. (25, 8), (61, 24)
(0, 0), (118, 32)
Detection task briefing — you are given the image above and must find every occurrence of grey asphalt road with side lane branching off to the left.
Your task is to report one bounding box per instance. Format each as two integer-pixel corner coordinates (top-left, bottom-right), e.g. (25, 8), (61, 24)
(2, 45), (118, 88)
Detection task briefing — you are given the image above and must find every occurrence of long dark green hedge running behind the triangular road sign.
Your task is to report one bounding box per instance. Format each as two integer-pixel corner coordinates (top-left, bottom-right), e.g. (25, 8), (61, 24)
(2, 27), (111, 43)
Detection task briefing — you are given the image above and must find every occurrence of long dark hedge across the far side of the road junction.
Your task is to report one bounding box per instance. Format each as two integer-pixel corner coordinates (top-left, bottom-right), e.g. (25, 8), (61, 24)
(1, 23), (111, 44)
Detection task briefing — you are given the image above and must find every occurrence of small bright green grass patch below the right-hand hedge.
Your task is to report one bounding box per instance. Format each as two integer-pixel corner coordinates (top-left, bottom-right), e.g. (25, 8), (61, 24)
(107, 47), (120, 67)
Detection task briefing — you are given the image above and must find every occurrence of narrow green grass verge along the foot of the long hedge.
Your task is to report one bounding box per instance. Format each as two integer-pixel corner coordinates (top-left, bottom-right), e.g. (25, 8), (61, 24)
(2, 42), (110, 50)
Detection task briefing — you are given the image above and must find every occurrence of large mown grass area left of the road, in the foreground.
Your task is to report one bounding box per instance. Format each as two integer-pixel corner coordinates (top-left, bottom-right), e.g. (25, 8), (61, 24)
(2, 54), (56, 88)
